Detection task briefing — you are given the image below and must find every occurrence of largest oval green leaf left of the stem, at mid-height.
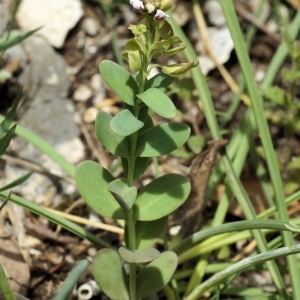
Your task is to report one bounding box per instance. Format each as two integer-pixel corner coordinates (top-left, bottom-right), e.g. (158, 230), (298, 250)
(75, 161), (124, 220)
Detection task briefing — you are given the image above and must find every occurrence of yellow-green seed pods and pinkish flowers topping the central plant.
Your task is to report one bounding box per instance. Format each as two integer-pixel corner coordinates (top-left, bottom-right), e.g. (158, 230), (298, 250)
(122, 0), (198, 77)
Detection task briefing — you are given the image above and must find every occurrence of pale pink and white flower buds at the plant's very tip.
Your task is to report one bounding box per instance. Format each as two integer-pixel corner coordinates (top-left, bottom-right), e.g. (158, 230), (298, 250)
(130, 0), (175, 20)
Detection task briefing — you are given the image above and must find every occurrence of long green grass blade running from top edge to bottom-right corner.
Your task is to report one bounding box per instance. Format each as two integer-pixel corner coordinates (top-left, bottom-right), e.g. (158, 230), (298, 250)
(221, 1), (300, 299)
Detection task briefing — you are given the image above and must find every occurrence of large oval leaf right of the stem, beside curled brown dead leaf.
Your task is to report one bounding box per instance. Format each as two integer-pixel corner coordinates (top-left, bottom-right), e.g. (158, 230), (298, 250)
(133, 174), (191, 221)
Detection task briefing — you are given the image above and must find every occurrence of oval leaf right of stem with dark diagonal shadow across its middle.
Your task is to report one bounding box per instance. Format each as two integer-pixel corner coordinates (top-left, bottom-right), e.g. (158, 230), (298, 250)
(136, 122), (191, 157)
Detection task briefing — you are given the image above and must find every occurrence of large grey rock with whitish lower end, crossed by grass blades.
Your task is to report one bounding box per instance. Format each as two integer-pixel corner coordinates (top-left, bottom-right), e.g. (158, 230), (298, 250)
(0, 36), (84, 205)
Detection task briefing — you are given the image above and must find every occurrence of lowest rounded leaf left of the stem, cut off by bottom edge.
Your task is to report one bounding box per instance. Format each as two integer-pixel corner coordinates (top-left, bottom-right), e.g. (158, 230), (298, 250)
(92, 249), (130, 300)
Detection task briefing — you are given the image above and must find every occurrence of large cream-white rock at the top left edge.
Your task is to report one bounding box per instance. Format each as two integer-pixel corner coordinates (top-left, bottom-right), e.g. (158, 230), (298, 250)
(16, 0), (83, 48)
